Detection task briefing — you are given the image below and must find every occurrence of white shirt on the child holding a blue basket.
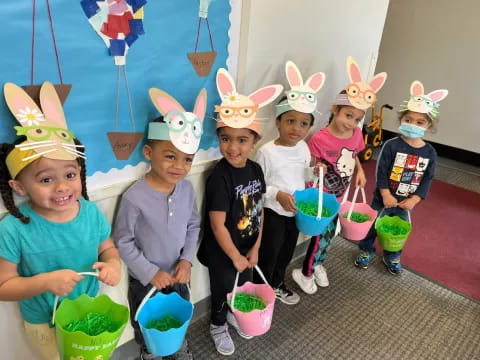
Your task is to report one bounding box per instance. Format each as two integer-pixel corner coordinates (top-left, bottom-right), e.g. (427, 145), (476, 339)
(255, 140), (310, 217)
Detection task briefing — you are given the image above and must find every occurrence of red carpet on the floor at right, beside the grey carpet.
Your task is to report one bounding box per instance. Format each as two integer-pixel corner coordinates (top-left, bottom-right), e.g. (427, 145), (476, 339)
(363, 161), (480, 301)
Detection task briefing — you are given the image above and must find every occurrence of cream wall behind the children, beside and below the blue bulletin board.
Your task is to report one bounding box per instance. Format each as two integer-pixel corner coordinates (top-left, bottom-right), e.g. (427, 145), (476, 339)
(0, 0), (388, 360)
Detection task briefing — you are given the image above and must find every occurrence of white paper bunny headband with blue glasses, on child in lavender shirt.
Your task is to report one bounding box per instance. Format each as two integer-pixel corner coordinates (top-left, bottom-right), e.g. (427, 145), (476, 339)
(148, 88), (207, 154)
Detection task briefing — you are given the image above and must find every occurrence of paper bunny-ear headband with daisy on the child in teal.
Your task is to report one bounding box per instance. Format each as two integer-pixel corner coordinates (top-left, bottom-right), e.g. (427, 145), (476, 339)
(3, 81), (85, 179)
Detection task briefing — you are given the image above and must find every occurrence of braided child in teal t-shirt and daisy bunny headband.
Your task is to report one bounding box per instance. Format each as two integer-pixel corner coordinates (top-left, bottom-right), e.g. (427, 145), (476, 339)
(0, 82), (120, 360)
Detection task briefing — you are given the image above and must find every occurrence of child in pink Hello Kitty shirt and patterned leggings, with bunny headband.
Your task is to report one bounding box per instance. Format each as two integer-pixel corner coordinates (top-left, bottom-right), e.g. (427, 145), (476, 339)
(292, 57), (387, 294)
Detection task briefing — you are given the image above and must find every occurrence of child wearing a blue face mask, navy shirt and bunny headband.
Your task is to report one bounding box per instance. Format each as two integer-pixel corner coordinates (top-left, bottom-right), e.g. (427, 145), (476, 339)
(355, 80), (448, 275)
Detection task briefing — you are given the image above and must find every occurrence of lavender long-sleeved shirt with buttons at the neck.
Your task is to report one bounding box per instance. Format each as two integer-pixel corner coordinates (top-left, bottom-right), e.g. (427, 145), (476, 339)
(113, 178), (200, 286)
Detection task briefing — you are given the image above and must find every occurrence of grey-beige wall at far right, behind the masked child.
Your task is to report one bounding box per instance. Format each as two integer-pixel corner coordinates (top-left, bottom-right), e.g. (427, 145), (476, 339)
(377, 0), (480, 153)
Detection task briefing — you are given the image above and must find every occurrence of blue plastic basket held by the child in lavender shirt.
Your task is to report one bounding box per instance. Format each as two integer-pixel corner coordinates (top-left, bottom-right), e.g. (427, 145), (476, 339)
(137, 292), (193, 356)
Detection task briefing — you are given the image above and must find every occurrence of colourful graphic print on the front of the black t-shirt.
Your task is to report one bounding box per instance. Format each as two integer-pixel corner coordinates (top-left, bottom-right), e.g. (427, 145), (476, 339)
(235, 180), (263, 238)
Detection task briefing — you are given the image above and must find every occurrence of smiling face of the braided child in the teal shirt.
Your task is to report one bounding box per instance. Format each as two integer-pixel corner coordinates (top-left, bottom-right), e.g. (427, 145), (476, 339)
(9, 157), (82, 222)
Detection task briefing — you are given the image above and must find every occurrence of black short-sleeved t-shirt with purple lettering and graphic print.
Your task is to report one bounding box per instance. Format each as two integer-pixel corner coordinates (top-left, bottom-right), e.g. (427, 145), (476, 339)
(198, 159), (266, 265)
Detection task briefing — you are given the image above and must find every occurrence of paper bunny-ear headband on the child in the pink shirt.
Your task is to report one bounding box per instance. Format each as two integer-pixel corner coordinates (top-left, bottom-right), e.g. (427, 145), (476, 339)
(335, 56), (387, 111)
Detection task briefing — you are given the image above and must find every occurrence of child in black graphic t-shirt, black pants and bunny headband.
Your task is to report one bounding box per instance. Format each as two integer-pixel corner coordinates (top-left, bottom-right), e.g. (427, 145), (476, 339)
(198, 69), (282, 355)
